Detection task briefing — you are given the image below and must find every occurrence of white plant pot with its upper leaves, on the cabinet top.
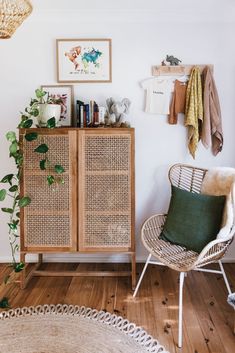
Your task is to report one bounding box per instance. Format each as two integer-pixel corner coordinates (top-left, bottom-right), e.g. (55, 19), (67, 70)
(30, 88), (62, 127)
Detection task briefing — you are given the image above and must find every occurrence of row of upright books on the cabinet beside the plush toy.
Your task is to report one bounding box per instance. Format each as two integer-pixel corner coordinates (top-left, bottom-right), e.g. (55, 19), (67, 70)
(76, 100), (106, 128)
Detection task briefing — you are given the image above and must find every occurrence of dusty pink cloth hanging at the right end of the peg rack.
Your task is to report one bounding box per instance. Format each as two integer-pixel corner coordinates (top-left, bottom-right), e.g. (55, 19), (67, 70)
(201, 66), (223, 156)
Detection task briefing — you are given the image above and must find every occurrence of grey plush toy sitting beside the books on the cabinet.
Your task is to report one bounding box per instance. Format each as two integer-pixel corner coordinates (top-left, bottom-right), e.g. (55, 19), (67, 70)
(105, 97), (131, 126)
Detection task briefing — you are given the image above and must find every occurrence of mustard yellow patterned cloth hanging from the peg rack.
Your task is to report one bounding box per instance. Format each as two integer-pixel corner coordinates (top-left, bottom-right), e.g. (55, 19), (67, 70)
(184, 66), (203, 158)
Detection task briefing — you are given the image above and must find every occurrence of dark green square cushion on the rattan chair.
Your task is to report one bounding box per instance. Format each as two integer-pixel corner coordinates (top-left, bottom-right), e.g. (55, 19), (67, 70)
(160, 186), (226, 253)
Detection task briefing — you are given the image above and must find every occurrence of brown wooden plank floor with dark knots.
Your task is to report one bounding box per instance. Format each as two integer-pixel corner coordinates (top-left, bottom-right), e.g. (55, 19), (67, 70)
(0, 264), (235, 353)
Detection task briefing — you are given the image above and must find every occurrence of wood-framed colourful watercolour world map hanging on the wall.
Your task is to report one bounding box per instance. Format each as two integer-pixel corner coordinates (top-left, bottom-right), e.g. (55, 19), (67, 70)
(56, 39), (112, 83)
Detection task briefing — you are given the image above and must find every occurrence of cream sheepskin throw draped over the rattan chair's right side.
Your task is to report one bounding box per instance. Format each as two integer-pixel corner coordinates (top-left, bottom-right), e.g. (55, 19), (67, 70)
(201, 167), (235, 239)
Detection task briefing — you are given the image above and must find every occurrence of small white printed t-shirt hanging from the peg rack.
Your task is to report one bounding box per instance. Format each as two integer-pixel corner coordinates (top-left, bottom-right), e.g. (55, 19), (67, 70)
(141, 78), (172, 115)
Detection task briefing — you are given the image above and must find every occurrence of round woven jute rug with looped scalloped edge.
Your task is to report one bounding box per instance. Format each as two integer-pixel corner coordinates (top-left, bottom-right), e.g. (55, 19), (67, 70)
(0, 304), (168, 353)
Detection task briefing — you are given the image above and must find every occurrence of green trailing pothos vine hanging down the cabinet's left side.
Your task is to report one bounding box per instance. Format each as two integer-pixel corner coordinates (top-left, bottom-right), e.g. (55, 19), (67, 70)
(0, 89), (65, 308)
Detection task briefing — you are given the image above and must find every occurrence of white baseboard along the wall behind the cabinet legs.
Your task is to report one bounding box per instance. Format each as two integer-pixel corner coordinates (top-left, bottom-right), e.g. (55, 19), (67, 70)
(0, 254), (235, 263)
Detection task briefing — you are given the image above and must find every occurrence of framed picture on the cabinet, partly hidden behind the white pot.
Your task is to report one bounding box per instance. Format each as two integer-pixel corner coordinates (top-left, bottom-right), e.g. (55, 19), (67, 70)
(41, 85), (74, 127)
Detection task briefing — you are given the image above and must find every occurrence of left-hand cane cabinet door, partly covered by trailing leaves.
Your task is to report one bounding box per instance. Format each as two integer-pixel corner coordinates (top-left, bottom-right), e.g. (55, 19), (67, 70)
(20, 129), (77, 252)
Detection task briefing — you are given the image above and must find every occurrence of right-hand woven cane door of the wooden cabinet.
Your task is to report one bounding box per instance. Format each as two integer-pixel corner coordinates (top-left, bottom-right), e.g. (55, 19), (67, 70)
(78, 129), (134, 252)
